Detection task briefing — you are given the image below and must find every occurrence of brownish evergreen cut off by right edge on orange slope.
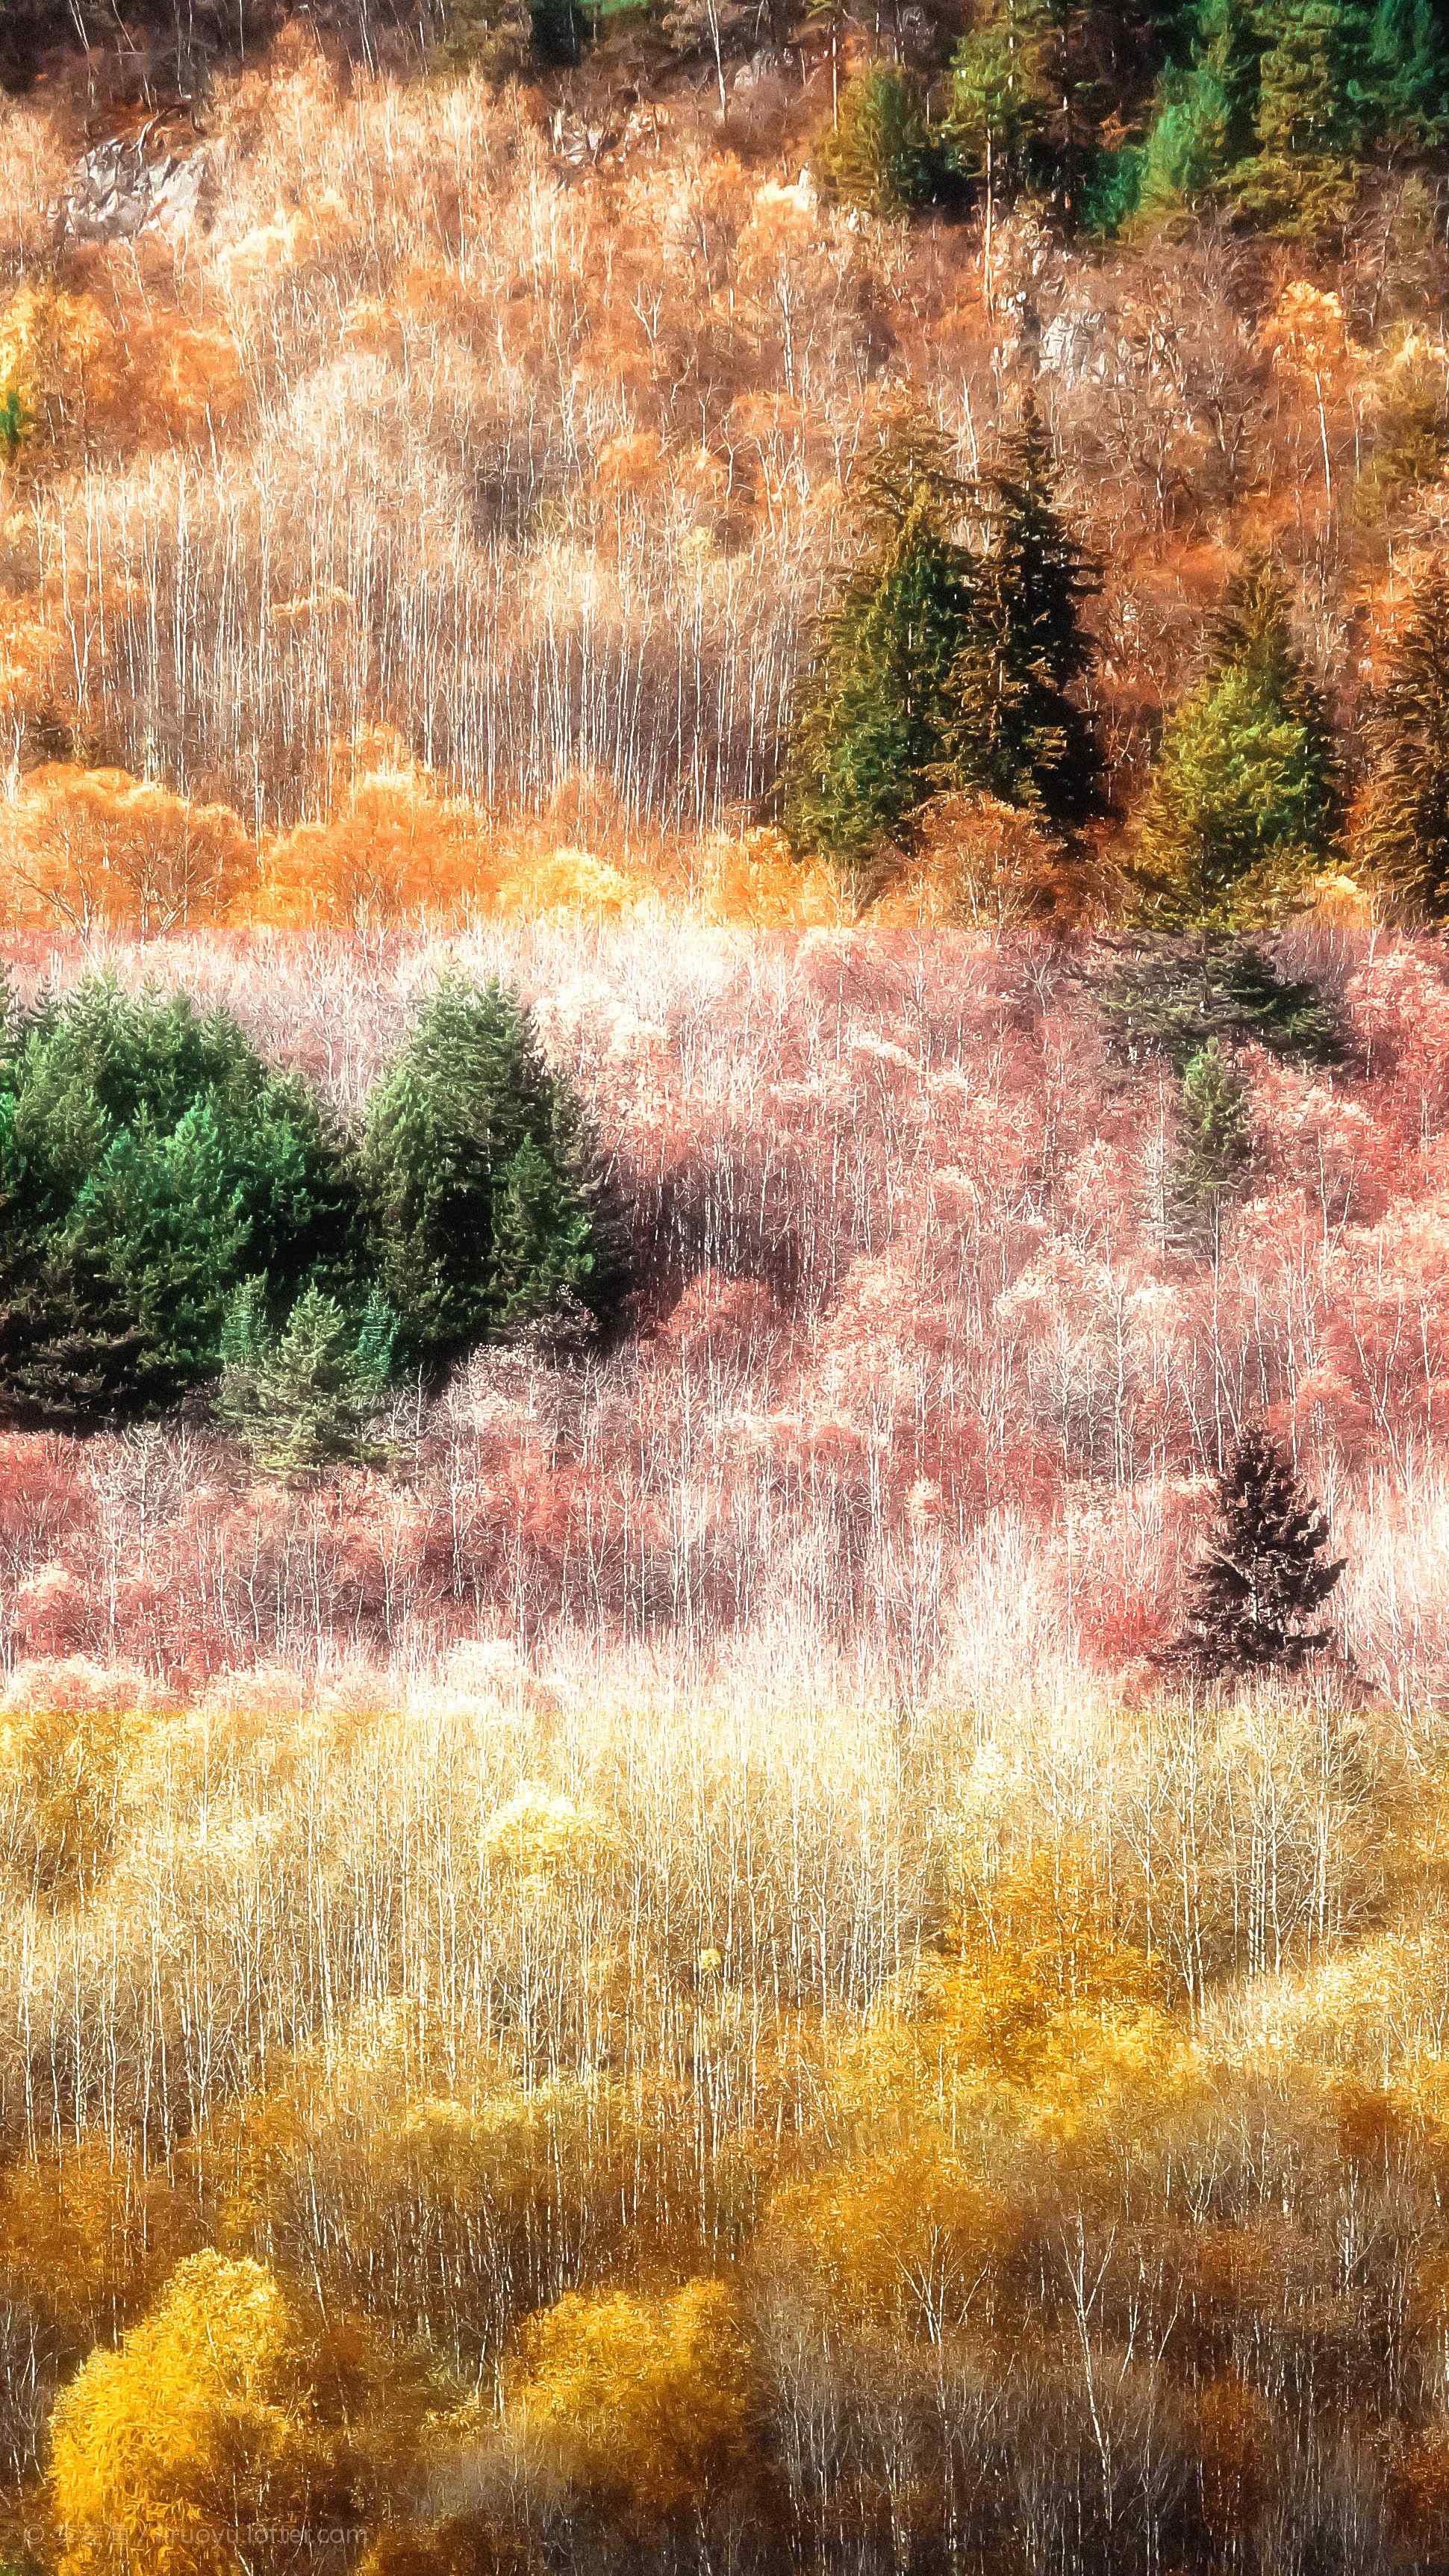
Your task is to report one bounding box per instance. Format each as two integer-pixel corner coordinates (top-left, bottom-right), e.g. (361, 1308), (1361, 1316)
(1359, 559), (1449, 922)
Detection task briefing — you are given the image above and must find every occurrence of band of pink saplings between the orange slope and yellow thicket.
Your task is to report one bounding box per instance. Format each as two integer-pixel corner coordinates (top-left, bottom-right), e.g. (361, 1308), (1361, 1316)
(0, 925), (1449, 1687)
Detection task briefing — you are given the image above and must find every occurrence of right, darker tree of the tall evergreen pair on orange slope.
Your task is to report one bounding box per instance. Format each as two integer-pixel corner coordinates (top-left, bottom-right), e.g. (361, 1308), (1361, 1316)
(944, 410), (1102, 830)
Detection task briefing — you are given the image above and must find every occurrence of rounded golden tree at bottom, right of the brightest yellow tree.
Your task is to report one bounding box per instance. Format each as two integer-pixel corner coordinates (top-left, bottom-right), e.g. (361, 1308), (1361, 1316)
(507, 2280), (757, 2524)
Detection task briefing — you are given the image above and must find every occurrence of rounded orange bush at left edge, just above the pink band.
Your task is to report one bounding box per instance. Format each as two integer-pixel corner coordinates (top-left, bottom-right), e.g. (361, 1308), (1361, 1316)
(0, 762), (255, 938)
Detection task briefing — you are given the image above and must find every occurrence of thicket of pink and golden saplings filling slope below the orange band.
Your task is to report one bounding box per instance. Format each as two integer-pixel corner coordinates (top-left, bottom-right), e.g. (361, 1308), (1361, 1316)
(0, 917), (1449, 2576)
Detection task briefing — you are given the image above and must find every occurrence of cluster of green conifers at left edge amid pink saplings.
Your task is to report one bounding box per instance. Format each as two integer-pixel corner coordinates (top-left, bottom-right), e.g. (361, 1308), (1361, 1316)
(0, 979), (617, 1466)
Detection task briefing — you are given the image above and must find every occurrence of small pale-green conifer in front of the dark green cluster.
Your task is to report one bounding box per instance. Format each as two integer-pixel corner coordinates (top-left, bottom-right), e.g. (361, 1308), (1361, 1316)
(216, 1281), (396, 1476)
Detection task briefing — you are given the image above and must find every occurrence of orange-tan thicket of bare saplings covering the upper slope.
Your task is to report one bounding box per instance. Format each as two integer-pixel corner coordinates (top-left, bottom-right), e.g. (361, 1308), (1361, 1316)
(0, 19), (1449, 935)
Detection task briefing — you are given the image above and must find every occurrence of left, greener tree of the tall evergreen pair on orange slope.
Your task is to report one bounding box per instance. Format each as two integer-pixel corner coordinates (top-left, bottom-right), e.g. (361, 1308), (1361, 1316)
(782, 430), (973, 868)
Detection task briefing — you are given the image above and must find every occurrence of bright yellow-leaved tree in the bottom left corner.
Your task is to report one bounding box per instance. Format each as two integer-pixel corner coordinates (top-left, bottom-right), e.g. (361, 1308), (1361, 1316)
(52, 2251), (399, 2576)
